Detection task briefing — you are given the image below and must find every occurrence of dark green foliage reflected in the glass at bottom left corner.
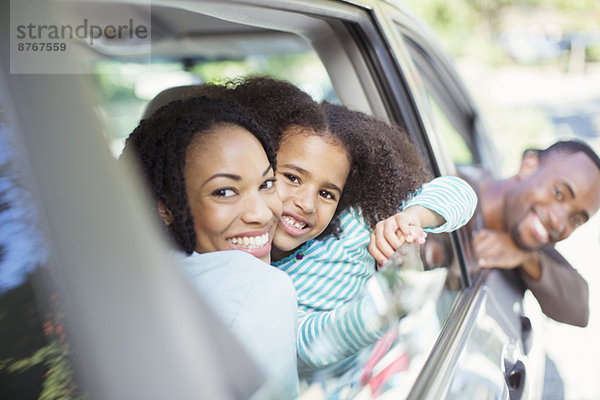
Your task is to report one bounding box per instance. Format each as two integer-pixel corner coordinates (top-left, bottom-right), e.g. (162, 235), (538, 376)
(0, 274), (86, 400)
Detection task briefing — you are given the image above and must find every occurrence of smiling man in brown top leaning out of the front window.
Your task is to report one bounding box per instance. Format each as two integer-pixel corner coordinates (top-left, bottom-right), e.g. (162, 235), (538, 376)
(460, 141), (600, 326)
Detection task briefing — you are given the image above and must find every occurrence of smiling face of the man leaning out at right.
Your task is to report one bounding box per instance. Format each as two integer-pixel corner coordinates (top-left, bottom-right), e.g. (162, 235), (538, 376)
(503, 152), (600, 250)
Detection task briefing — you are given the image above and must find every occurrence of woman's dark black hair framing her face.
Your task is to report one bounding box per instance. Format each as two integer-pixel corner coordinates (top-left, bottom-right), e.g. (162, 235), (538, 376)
(121, 97), (276, 254)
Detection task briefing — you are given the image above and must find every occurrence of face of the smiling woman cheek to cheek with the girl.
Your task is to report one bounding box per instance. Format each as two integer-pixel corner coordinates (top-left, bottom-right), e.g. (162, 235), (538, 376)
(184, 125), (281, 263)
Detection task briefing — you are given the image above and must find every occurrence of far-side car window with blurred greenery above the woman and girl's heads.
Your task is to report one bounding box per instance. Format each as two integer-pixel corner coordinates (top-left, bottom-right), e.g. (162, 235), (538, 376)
(92, 47), (339, 156)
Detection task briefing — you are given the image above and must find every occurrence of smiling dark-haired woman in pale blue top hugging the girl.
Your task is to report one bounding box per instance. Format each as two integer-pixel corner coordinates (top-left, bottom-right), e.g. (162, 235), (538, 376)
(122, 97), (298, 398)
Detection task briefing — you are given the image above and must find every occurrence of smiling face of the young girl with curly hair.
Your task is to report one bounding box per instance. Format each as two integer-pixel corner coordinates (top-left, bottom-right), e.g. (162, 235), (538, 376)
(273, 128), (350, 258)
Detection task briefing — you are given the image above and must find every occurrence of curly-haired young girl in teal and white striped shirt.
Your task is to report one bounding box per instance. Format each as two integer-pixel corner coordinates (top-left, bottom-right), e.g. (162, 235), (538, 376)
(195, 77), (476, 369)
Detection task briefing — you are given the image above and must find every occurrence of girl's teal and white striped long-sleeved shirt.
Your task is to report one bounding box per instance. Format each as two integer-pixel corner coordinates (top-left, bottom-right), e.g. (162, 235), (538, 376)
(272, 176), (477, 370)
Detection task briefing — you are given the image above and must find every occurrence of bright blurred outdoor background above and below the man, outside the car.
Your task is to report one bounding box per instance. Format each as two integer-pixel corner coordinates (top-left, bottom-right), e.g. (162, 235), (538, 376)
(408, 0), (600, 400)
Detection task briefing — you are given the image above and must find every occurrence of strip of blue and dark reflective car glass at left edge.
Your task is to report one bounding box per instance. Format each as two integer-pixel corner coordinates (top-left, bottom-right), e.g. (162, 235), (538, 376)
(0, 82), (83, 399)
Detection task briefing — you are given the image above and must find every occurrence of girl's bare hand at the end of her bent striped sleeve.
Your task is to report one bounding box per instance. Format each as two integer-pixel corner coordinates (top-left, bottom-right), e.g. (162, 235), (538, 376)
(369, 210), (427, 265)
